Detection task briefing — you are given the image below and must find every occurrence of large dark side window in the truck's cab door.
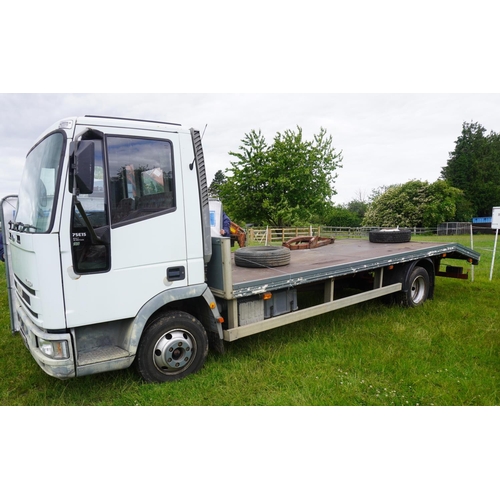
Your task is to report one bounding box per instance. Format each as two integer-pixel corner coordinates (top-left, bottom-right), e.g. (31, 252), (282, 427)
(107, 137), (175, 225)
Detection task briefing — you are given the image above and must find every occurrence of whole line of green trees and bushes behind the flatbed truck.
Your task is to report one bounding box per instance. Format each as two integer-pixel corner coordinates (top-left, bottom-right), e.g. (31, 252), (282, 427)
(210, 122), (500, 227)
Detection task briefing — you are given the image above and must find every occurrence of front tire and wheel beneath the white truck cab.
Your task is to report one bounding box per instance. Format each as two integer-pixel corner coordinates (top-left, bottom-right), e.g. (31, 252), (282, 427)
(135, 311), (208, 383)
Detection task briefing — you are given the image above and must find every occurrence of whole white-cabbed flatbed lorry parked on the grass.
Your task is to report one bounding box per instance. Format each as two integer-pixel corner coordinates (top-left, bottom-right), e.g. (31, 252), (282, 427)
(0, 116), (480, 382)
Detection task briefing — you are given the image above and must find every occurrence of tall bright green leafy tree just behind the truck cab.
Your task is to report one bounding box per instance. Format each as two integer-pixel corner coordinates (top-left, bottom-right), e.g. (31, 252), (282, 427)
(220, 127), (342, 227)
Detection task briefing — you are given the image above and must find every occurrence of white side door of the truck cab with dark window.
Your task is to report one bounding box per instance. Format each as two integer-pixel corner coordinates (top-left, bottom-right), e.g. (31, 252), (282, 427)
(61, 127), (188, 327)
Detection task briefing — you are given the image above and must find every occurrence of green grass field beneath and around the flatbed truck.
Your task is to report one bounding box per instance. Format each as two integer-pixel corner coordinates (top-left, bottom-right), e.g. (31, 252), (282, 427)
(0, 235), (500, 406)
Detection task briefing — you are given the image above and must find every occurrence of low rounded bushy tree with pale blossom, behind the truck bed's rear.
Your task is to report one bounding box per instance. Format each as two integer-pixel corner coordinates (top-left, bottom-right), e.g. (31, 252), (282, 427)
(363, 180), (463, 227)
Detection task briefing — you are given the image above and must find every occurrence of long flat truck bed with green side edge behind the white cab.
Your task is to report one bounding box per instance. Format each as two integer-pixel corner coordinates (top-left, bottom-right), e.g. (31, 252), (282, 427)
(207, 238), (480, 341)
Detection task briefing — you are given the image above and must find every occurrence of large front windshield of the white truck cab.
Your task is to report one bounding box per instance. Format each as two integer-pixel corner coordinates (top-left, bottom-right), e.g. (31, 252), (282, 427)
(15, 132), (65, 233)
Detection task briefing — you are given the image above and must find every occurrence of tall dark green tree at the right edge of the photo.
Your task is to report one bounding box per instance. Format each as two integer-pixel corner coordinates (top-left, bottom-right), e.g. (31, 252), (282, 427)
(441, 122), (500, 217)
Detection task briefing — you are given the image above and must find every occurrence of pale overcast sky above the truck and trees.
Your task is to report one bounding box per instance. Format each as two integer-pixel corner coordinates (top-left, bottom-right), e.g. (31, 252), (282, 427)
(0, 93), (500, 204)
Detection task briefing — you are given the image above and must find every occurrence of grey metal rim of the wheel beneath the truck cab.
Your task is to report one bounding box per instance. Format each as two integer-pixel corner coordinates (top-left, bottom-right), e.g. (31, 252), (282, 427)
(153, 330), (196, 373)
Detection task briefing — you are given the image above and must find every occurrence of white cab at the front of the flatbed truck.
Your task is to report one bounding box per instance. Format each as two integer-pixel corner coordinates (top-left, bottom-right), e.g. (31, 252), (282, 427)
(2, 116), (222, 381)
